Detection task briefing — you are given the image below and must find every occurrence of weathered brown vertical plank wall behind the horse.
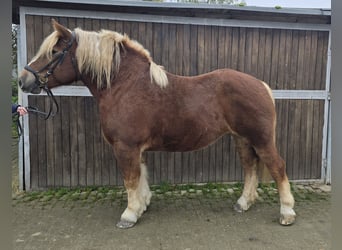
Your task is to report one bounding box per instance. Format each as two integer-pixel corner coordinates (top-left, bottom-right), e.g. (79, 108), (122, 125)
(26, 15), (328, 189)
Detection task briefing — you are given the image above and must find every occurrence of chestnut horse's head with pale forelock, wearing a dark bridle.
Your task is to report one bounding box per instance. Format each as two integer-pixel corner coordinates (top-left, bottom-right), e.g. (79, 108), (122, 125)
(19, 20), (78, 94)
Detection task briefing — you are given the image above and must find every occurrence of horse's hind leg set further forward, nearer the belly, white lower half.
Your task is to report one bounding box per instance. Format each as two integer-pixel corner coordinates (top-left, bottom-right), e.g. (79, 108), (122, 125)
(234, 136), (259, 212)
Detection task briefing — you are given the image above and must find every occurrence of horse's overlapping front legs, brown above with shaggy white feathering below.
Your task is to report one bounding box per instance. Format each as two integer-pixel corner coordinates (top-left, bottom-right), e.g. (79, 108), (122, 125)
(114, 144), (152, 229)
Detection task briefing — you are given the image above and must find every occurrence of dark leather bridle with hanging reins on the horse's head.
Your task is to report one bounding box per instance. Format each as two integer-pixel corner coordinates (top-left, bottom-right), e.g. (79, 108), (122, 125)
(24, 31), (80, 120)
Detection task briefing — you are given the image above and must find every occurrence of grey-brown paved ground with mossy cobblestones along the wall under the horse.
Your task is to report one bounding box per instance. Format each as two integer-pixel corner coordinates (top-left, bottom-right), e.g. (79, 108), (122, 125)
(13, 184), (331, 250)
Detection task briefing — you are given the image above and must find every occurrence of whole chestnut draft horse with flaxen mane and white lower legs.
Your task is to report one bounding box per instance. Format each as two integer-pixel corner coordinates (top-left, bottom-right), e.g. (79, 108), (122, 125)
(19, 20), (296, 228)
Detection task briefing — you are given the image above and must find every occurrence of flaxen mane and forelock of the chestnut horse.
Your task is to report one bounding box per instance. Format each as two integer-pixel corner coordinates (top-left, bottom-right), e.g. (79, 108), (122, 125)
(32, 28), (168, 88)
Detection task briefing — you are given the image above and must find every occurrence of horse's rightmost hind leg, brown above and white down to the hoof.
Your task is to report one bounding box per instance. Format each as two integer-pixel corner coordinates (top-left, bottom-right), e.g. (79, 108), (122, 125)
(256, 143), (296, 225)
